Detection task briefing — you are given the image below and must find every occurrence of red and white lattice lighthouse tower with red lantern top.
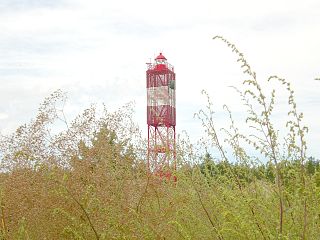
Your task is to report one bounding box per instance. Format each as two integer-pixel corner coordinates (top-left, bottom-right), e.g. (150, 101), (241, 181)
(147, 53), (176, 179)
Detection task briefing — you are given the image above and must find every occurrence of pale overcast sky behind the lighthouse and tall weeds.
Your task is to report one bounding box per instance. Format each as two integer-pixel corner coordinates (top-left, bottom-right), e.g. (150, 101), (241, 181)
(0, 0), (320, 158)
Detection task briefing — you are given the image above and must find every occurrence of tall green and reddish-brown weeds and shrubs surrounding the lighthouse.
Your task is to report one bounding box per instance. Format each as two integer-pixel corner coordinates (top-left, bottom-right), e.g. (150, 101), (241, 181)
(0, 37), (320, 239)
